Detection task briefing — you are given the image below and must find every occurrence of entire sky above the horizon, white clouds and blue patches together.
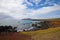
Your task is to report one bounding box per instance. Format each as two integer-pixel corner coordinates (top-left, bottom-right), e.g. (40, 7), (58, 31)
(0, 0), (60, 20)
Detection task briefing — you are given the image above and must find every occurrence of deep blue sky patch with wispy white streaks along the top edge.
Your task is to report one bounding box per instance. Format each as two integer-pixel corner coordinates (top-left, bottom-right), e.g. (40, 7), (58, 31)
(24, 0), (60, 10)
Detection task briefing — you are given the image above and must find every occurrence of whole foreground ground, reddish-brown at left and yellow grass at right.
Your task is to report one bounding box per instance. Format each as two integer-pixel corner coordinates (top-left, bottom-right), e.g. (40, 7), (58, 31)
(0, 27), (60, 40)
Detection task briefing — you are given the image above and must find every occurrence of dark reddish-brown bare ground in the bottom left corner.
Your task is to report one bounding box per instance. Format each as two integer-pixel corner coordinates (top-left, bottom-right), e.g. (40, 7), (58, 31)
(0, 32), (32, 40)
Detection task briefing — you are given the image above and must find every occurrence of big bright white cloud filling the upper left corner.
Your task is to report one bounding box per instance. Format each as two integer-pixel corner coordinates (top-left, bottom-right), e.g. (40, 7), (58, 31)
(0, 0), (26, 17)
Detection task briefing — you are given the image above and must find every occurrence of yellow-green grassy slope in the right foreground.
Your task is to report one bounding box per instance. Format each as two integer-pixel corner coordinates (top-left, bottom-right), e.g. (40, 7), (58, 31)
(22, 27), (60, 40)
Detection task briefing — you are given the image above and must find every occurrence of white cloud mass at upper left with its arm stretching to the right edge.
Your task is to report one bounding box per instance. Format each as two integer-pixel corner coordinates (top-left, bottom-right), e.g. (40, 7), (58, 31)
(0, 0), (60, 19)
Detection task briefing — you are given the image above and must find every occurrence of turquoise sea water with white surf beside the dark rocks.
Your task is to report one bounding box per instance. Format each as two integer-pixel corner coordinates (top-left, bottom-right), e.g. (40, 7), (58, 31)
(18, 20), (40, 31)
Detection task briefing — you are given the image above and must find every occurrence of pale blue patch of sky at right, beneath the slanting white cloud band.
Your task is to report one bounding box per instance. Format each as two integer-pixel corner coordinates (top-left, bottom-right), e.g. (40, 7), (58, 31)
(35, 10), (60, 18)
